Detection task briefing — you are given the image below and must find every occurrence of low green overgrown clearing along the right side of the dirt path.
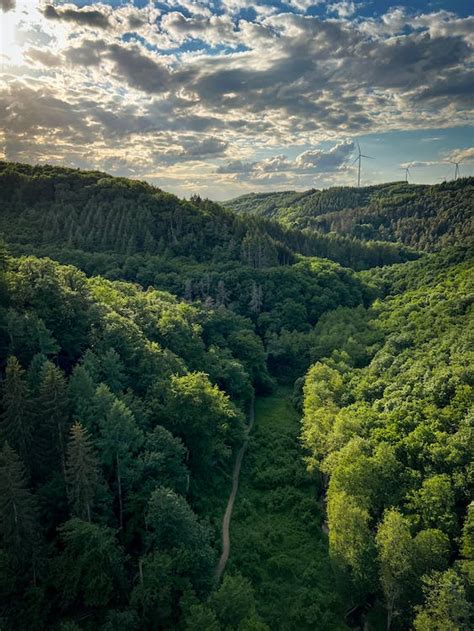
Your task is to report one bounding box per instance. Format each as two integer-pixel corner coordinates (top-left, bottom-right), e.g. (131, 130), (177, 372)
(227, 387), (347, 631)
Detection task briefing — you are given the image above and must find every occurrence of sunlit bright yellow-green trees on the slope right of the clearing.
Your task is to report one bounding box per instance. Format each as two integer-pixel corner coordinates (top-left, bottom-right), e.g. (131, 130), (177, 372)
(301, 249), (473, 629)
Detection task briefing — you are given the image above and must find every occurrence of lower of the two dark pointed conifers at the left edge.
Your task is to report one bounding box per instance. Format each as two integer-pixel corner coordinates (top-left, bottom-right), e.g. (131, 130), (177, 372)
(0, 442), (36, 560)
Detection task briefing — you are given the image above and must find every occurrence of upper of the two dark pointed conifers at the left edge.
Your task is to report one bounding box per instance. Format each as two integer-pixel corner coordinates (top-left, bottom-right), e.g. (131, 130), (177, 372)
(1, 356), (31, 462)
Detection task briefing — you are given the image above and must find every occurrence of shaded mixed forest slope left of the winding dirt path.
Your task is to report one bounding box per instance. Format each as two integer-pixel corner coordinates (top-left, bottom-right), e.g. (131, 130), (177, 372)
(0, 249), (269, 628)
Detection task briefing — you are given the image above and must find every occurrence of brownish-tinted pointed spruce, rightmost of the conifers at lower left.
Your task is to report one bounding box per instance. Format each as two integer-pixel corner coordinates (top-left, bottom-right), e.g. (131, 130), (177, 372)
(66, 421), (98, 521)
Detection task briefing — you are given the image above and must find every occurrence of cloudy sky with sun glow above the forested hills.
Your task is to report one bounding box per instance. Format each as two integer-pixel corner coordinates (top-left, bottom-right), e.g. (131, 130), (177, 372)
(0, 0), (474, 200)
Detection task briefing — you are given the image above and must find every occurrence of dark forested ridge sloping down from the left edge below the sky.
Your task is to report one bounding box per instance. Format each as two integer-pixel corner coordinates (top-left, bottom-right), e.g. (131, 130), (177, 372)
(0, 162), (416, 271)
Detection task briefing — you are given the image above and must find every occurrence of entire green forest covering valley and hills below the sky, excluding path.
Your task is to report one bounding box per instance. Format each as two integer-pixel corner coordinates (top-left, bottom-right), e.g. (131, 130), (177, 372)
(0, 162), (474, 631)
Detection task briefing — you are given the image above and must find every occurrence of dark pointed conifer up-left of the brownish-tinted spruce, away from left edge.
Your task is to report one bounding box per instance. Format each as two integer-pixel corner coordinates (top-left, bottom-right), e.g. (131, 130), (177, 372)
(38, 361), (69, 477)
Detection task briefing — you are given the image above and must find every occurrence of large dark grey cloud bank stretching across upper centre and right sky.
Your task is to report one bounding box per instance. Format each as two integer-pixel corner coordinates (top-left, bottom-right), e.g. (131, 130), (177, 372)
(55, 7), (470, 133)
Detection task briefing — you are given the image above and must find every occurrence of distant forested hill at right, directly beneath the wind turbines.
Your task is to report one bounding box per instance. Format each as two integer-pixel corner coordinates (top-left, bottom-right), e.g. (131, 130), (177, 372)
(225, 177), (474, 251)
